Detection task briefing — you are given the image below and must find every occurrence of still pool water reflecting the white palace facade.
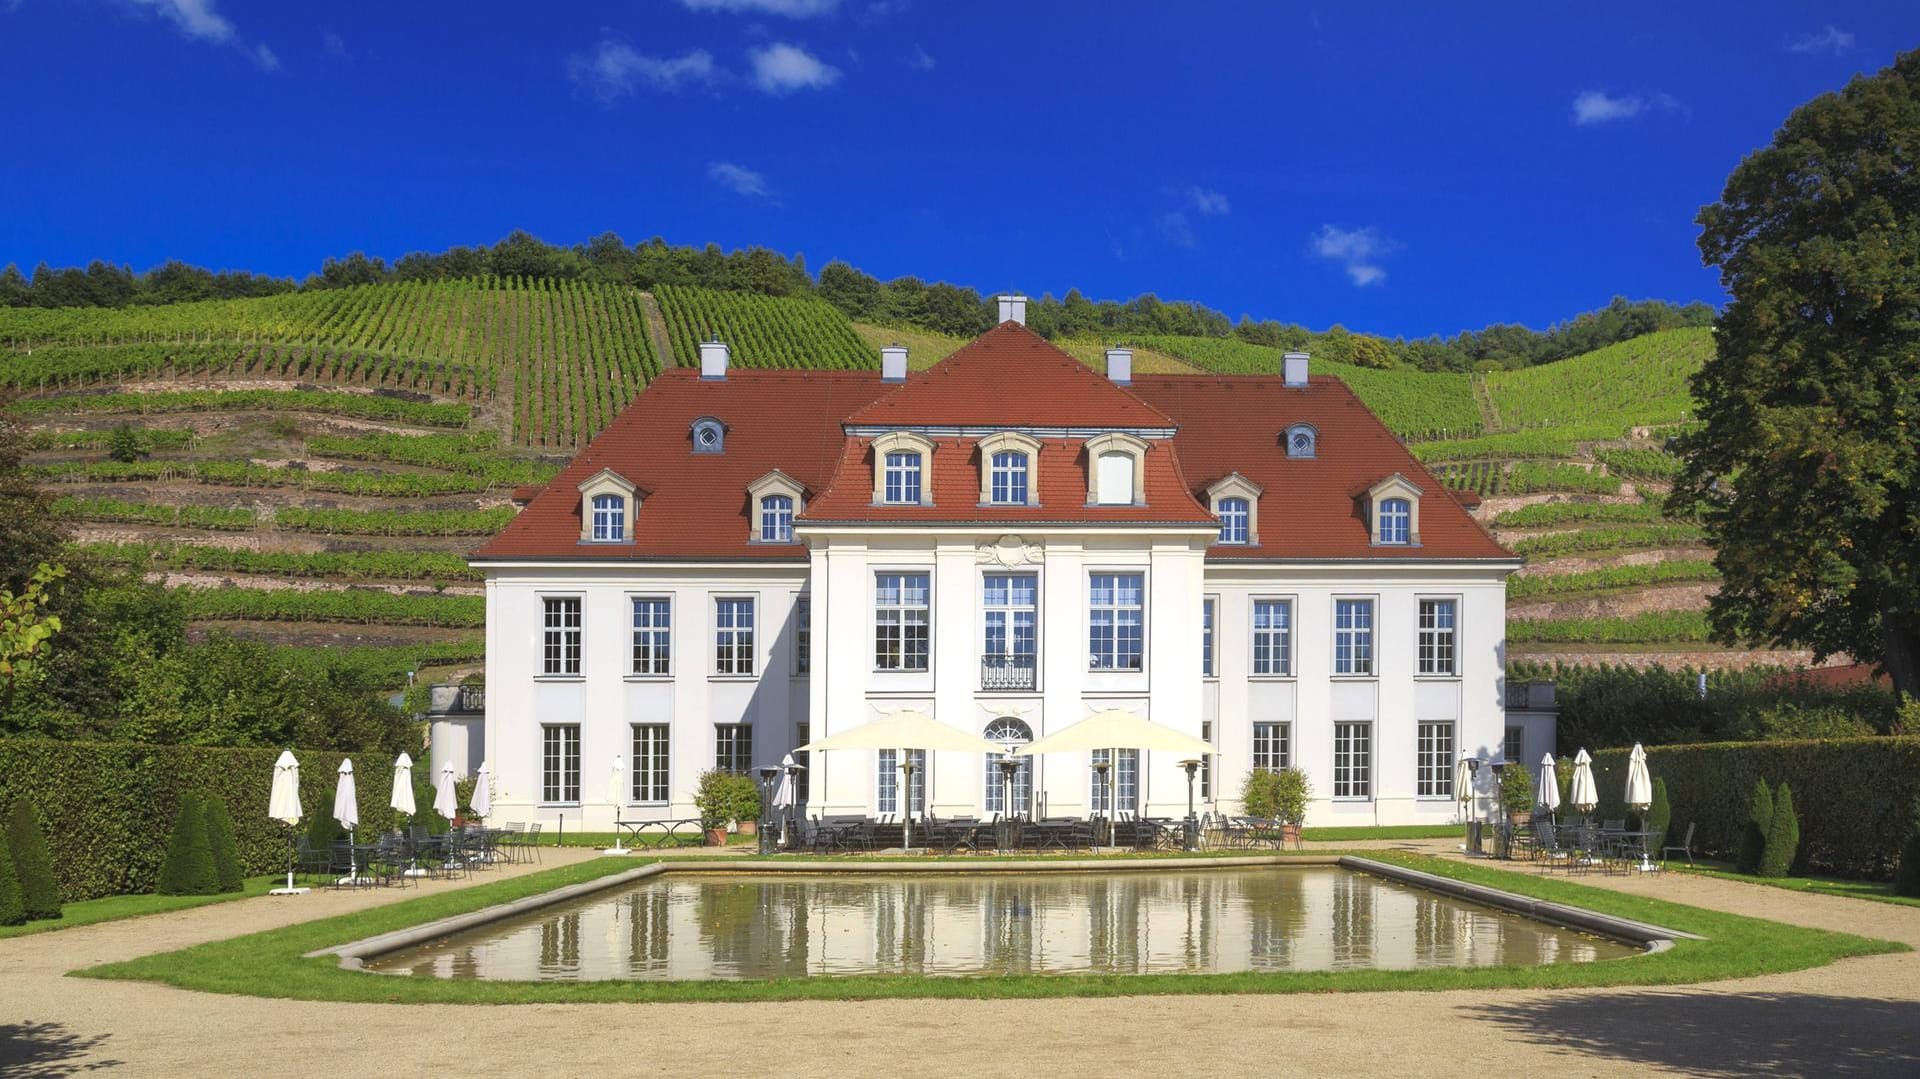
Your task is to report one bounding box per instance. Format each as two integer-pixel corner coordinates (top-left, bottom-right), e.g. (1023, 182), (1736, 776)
(367, 866), (1636, 981)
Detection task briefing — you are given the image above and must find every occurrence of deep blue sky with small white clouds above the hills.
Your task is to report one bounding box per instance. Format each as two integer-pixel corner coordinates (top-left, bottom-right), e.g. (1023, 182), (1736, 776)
(0, 0), (1920, 334)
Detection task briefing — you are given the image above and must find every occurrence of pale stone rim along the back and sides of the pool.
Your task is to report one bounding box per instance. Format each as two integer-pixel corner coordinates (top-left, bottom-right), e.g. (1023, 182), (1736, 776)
(301, 854), (1701, 970)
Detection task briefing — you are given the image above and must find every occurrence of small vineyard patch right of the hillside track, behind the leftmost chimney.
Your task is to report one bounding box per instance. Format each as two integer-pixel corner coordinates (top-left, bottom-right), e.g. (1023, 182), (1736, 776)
(653, 284), (879, 371)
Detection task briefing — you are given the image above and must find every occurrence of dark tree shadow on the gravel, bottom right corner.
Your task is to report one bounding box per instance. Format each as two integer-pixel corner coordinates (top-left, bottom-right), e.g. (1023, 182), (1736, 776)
(1463, 993), (1920, 1075)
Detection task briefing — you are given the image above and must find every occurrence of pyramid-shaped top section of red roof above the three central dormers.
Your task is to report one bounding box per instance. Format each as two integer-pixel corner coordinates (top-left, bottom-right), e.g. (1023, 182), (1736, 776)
(847, 323), (1173, 428)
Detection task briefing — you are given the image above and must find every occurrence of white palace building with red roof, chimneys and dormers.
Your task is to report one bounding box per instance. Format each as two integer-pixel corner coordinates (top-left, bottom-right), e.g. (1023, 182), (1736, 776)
(472, 298), (1520, 831)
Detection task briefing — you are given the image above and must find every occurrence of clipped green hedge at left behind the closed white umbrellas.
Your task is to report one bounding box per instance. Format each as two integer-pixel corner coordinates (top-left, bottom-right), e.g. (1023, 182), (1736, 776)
(0, 739), (392, 902)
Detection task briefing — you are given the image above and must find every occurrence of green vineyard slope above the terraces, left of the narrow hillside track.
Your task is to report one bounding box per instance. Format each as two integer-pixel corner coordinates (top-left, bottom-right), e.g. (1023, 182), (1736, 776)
(0, 278), (660, 449)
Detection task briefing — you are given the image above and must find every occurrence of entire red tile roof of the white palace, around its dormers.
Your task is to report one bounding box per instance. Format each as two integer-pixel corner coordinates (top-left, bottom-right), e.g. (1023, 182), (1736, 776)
(474, 323), (1513, 561)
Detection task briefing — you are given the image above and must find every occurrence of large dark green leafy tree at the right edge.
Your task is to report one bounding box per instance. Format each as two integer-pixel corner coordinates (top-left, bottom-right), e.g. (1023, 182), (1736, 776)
(1676, 52), (1920, 695)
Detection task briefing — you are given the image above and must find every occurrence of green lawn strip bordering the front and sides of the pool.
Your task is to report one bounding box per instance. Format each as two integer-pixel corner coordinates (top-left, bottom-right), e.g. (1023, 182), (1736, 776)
(75, 852), (1903, 1004)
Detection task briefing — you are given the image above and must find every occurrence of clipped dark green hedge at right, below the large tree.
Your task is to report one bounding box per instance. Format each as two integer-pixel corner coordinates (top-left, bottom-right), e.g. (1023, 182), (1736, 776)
(1594, 737), (1920, 879)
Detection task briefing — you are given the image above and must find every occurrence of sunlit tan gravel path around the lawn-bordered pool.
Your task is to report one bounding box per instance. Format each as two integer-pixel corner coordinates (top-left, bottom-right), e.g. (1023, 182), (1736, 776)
(0, 843), (1920, 1077)
